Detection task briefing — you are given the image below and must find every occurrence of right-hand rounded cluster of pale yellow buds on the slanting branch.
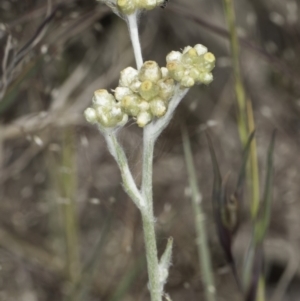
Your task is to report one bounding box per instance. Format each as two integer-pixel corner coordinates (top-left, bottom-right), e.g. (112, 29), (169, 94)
(167, 44), (216, 88)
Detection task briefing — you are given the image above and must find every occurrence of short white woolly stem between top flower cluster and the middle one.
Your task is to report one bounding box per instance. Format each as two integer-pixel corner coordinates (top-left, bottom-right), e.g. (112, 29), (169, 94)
(127, 12), (143, 70)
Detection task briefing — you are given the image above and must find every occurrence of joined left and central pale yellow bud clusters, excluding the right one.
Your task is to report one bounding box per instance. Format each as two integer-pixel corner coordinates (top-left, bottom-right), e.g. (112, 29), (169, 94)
(85, 61), (175, 128)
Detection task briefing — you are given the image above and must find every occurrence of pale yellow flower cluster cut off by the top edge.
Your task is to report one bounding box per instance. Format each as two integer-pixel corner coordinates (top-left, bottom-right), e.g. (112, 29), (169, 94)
(117, 0), (165, 15)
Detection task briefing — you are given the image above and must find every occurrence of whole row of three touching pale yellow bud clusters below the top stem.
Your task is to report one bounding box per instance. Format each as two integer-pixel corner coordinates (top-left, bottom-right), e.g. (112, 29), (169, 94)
(85, 44), (215, 128)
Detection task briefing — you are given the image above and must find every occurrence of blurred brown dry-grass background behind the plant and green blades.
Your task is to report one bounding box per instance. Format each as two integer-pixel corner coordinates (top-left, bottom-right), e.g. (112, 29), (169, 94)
(0, 0), (300, 301)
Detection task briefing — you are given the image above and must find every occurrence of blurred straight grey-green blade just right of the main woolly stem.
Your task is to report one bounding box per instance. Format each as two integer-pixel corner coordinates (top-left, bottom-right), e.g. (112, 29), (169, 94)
(181, 125), (216, 301)
